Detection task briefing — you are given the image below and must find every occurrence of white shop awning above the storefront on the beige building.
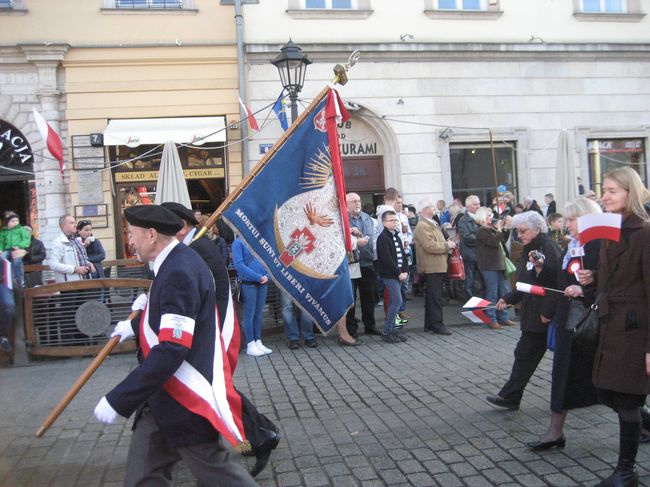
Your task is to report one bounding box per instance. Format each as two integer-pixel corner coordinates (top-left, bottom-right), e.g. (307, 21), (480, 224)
(104, 117), (226, 147)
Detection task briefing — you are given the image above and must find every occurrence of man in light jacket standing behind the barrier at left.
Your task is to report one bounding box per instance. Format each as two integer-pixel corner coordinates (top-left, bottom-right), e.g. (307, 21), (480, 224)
(47, 215), (95, 282)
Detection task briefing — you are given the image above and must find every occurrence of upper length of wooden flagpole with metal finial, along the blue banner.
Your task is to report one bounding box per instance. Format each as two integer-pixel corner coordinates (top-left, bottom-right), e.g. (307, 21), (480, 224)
(192, 51), (359, 241)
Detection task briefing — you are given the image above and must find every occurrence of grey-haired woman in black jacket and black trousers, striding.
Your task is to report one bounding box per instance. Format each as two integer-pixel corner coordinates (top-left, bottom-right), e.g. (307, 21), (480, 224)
(486, 211), (560, 410)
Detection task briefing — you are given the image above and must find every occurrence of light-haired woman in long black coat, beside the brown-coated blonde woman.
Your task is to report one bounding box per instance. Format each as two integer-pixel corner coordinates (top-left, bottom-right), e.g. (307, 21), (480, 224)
(528, 198), (602, 450)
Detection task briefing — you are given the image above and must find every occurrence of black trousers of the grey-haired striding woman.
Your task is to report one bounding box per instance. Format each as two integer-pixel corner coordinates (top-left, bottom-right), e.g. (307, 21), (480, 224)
(499, 331), (546, 402)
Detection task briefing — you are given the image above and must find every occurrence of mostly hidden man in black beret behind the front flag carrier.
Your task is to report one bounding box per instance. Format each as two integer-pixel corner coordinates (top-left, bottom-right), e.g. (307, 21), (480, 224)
(161, 202), (280, 477)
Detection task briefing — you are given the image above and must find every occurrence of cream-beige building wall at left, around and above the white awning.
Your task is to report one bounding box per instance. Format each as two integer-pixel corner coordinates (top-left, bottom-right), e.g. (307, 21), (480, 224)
(0, 0), (242, 259)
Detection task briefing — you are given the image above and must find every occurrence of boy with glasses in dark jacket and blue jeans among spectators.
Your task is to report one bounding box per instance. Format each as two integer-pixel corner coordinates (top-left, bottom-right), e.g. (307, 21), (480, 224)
(375, 210), (408, 343)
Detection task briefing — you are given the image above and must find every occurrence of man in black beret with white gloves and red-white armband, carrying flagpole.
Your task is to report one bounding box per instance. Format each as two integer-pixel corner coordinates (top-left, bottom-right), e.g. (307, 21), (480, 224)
(95, 205), (257, 486)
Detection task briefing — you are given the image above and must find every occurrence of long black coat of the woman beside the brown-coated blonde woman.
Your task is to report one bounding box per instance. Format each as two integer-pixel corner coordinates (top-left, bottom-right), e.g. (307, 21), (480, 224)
(551, 240), (600, 413)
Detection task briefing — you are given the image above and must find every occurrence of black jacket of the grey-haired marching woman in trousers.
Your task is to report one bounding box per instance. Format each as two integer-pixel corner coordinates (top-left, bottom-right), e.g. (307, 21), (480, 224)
(503, 233), (560, 333)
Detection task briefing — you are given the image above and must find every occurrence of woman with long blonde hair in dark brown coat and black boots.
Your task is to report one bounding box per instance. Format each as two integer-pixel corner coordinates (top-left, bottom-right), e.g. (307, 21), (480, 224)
(578, 167), (650, 487)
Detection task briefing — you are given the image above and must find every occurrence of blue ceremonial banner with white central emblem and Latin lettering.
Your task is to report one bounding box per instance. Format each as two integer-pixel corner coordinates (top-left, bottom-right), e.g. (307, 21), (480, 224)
(223, 93), (353, 332)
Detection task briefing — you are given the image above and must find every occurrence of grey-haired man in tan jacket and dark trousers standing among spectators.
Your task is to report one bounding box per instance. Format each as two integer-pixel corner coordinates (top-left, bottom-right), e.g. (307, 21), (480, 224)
(413, 199), (456, 335)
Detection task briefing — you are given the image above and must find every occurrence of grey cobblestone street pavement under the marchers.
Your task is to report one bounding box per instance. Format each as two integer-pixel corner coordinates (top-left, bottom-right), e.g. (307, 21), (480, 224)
(0, 300), (650, 487)
